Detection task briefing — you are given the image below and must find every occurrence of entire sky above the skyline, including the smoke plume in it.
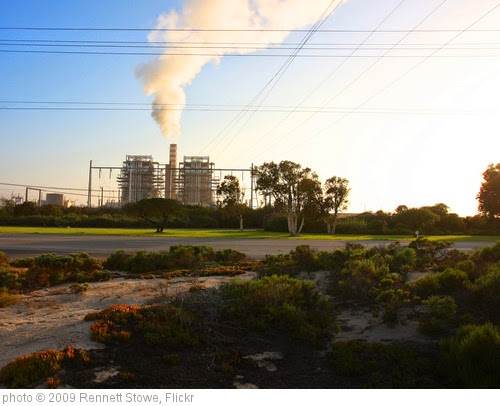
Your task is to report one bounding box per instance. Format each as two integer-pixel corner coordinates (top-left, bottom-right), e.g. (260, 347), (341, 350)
(0, 0), (500, 216)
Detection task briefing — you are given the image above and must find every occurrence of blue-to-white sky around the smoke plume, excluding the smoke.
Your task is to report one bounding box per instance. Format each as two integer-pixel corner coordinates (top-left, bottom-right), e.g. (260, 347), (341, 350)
(0, 0), (500, 215)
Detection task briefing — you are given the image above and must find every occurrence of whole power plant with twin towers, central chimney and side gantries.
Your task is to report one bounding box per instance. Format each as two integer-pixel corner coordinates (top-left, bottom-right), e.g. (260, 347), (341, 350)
(87, 144), (257, 207)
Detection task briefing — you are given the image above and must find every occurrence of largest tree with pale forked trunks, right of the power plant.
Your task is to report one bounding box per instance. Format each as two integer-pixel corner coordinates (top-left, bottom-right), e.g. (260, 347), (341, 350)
(253, 161), (321, 237)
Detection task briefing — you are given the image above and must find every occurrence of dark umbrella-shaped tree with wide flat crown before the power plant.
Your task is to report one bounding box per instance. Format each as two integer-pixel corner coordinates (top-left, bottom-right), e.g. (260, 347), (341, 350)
(125, 198), (183, 233)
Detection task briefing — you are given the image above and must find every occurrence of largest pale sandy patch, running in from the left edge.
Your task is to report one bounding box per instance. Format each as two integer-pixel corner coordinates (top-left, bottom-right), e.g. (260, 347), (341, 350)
(0, 272), (255, 368)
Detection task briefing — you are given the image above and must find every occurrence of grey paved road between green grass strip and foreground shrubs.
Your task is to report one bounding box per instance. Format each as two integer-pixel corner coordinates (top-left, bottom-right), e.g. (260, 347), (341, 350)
(0, 234), (495, 259)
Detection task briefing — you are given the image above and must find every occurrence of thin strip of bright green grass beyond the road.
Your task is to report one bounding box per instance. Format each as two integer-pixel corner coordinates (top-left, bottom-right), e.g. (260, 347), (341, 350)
(0, 226), (500, 242)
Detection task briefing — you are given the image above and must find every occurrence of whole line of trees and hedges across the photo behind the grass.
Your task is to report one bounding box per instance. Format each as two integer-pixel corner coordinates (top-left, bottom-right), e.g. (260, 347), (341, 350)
(0, 161), (500, 236)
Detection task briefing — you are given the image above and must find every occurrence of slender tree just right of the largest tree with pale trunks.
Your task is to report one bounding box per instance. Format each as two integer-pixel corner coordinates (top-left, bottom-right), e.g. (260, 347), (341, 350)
(324, 176), (351, 234)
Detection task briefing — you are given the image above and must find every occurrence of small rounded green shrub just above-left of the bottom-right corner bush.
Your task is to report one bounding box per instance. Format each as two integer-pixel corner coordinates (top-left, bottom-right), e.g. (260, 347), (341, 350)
(419, 296), (457, 337)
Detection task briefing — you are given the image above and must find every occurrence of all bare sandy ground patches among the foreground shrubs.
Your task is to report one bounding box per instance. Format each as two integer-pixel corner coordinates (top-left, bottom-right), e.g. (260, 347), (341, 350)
(0, 272), (430, 376)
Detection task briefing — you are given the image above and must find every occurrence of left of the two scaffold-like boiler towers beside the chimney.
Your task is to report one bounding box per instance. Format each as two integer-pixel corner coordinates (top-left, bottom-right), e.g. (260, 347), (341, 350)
(117, 155), (165, 204)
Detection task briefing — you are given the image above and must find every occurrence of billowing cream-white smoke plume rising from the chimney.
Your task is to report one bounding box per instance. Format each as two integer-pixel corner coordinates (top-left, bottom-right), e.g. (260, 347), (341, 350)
(135, 0), (331, 140)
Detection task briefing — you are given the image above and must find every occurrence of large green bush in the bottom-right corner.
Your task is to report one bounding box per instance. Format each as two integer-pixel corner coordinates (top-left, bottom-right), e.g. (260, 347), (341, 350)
(440, 323), (500, 389)
